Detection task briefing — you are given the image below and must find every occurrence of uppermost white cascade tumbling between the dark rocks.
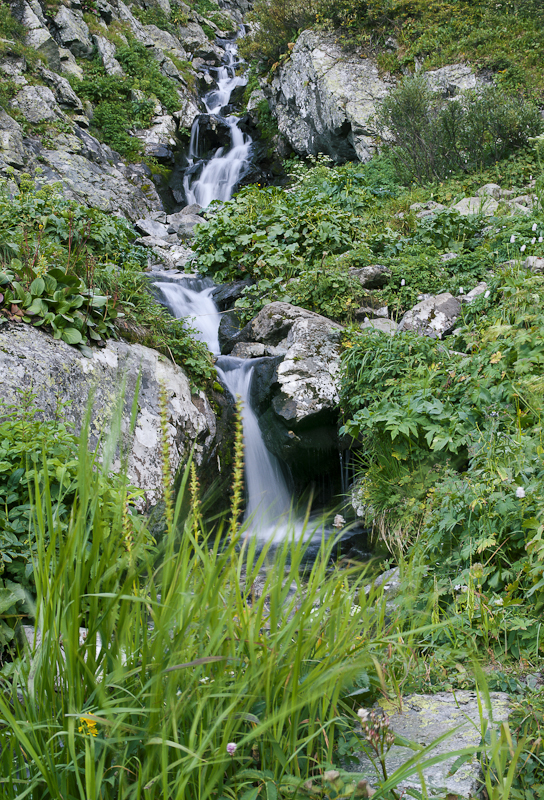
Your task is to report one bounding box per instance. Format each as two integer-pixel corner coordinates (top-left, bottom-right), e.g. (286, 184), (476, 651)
(183, 41), (252, 208)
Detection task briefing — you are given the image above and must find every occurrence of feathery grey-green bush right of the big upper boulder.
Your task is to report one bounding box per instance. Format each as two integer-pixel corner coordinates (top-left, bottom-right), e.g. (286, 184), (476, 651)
(376, 75), (542, 183)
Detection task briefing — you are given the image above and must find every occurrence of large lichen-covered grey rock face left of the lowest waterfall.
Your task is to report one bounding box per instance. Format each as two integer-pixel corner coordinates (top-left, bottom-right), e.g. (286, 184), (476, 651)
(0, 324), (215, 505)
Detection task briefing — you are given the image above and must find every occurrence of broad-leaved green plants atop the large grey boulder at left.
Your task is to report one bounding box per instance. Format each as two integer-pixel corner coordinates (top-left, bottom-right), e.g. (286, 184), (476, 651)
(0, 176), (215, 384)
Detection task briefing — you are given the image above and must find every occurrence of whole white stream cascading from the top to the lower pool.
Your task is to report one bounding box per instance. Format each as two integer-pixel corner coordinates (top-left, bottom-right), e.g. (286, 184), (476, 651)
(154, 40), (368, 550)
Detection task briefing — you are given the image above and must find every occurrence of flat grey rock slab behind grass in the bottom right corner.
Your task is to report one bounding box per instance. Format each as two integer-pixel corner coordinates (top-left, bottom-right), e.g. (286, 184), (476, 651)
(354, 691), (510, 800)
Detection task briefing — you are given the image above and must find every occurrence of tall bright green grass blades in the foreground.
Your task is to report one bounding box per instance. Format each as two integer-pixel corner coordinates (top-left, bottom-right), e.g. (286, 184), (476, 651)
(0, 410), (517, 800)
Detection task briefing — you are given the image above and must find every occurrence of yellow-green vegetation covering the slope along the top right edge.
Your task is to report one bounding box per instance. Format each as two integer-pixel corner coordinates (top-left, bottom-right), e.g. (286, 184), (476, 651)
(243, 0), (544, 99)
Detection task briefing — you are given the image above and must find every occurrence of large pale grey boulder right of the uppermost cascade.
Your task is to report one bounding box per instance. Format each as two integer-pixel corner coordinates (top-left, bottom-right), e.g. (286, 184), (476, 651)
(265, 31), (394, 162)
